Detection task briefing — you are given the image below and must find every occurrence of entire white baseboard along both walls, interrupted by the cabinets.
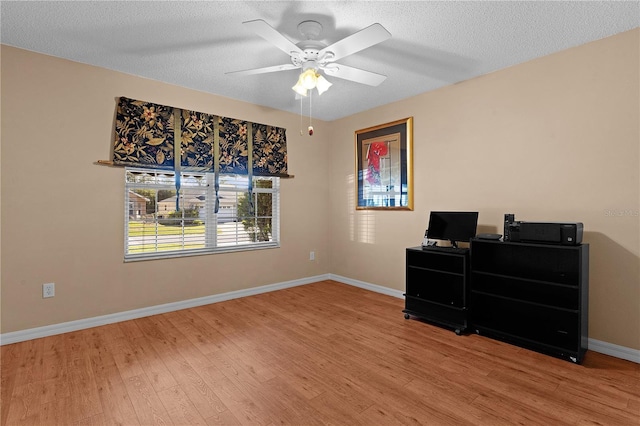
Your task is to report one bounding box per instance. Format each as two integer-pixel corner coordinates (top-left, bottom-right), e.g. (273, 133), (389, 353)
(0, 274), (640, 364)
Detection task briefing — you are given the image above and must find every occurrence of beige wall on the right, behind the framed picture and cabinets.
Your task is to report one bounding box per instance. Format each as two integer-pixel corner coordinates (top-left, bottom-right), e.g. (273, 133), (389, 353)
(330, 30), (640, 349)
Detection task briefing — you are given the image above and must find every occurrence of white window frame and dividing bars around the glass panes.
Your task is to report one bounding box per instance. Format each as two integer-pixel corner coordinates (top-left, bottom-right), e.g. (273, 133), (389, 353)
(124, 167), (280, 262)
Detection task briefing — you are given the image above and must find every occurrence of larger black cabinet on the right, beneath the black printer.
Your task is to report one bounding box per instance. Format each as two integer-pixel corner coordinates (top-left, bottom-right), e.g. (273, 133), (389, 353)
(470, 239), (589, 363)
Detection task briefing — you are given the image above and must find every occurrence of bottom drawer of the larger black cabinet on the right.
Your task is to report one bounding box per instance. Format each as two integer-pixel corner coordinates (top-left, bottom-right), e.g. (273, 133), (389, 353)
(471, 291), (580, 351)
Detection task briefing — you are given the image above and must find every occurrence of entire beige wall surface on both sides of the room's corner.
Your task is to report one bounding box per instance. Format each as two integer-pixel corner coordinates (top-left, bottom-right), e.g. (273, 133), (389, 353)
(0, 30), (640, 349)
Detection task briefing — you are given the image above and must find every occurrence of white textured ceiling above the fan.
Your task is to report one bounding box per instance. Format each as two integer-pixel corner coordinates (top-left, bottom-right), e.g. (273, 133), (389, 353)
(0, 1), (640, 121)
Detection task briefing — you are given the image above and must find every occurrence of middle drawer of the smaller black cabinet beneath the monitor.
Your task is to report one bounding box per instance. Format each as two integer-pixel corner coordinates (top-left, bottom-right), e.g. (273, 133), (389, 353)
(406, 266), (465, 308)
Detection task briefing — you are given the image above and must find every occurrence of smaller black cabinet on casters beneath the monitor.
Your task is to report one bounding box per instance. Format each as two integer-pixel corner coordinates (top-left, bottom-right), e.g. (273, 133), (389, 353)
(403, 247), (469, 334)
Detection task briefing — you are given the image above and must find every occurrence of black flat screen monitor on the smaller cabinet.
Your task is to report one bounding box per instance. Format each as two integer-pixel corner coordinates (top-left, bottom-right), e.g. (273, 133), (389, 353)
(427, 212), (478, 247)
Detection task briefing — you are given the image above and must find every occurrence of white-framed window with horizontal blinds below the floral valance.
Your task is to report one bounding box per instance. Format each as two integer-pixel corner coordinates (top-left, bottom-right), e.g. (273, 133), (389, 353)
(124, 168), (280, 260)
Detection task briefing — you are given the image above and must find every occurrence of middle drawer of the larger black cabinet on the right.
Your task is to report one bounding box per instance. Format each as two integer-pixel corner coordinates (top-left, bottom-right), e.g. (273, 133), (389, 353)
(471, 272), (580, 310)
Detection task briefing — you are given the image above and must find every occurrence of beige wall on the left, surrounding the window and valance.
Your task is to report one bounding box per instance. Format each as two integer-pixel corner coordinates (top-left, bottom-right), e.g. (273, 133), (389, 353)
(1, 46), (329, 333)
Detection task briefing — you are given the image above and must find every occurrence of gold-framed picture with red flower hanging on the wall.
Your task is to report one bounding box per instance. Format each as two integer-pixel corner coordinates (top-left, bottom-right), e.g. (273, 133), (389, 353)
(355, 117), (413, 210)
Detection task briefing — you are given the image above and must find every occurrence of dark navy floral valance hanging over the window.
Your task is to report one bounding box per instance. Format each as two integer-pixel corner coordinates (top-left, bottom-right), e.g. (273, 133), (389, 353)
(113, 97), (289, 177)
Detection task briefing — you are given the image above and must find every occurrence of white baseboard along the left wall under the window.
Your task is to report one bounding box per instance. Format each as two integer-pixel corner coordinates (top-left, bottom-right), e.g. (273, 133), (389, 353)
(0, 274), (330, 346)
